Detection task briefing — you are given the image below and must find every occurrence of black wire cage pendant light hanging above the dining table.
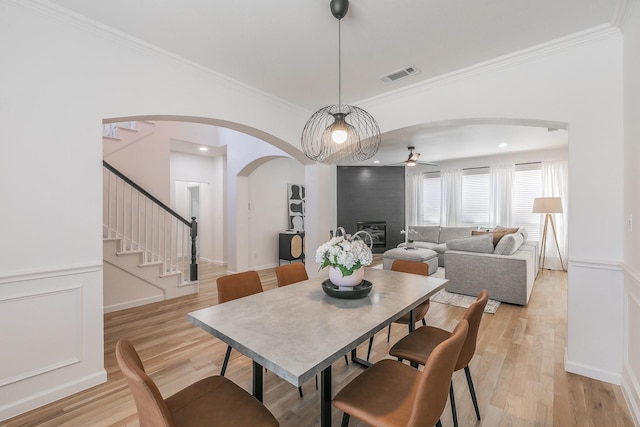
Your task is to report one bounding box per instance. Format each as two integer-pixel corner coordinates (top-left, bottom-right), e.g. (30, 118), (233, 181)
(301, 0), (380, 164)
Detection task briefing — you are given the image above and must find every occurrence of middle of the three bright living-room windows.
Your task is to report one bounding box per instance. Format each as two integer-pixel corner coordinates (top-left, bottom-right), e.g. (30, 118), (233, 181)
(461, 168), (490, 227)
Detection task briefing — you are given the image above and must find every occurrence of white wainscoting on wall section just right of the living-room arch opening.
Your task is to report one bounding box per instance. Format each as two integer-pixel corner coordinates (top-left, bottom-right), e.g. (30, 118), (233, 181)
(565, 259), (625, 385)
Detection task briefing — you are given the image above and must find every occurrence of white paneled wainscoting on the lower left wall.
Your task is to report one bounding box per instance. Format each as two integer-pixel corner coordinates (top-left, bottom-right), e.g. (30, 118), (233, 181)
(0, 263), (106, 421)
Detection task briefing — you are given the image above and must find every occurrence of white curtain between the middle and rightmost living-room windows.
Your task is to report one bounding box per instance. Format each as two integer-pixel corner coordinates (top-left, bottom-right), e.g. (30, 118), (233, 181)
(489, 165), (515, 227)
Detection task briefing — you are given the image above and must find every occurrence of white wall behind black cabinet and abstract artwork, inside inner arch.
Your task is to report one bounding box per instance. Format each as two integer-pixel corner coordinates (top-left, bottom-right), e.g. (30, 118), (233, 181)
(249, 159), (304, 270)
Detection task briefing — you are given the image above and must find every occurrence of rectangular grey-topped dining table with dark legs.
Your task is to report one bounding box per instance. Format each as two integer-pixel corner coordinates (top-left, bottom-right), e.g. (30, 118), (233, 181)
(187, 268), (447, 427)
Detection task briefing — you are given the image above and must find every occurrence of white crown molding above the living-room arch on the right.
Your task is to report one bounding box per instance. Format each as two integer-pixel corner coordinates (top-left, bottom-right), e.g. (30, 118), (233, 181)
(356, 23), (624, 106)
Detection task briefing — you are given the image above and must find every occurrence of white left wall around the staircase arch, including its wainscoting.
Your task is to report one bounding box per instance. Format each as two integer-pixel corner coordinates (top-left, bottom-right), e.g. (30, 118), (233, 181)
(0, 0), (308, 419)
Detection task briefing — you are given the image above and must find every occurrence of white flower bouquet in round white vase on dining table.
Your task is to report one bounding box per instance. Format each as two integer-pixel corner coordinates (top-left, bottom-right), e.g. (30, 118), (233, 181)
(316, 227), (373, 290)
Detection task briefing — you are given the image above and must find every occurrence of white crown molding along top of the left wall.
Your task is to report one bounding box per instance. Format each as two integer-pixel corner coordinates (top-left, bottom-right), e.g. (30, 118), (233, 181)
(0, 0), (307, 114)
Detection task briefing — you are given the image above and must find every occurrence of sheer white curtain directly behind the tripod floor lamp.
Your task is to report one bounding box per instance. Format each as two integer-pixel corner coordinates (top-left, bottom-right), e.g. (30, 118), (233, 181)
(540, 161), (569, 270)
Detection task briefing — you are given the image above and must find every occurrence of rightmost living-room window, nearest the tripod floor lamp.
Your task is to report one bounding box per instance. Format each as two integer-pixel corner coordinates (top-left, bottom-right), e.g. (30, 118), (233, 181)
(513, 163), (542, 241)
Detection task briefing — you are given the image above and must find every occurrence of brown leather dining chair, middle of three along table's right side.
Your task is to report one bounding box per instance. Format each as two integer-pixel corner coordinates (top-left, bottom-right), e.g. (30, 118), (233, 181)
(389, 289), (489, 427)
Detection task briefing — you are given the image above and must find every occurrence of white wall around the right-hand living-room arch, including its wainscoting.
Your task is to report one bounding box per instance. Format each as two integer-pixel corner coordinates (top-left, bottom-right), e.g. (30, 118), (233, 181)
(362, 30), (623, 383)
